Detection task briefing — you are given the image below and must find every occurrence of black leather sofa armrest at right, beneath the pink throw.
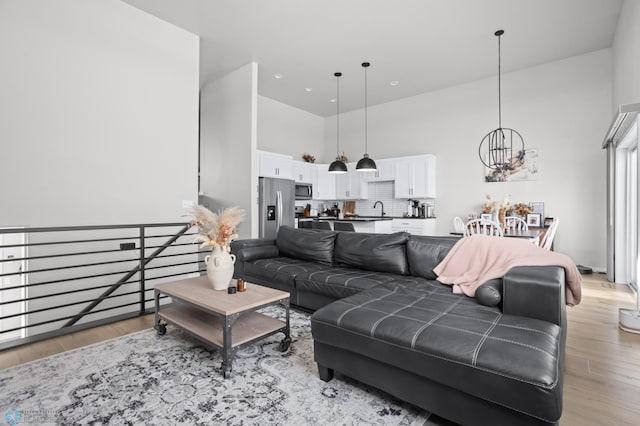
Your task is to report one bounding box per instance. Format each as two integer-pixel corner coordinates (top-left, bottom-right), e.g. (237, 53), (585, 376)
(502, 266), (566, 328)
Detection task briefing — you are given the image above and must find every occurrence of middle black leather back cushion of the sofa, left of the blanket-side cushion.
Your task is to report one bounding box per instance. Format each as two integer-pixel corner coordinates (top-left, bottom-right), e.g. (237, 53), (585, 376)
(334, 232), (409, 275)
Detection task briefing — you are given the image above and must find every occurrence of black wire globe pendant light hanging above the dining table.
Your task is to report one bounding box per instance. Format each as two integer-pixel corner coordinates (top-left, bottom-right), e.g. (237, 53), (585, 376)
(478, 30), (524, 177)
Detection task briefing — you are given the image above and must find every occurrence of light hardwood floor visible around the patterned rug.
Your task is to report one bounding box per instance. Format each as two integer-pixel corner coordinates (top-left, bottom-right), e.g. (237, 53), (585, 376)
(0, 274), (640, 426)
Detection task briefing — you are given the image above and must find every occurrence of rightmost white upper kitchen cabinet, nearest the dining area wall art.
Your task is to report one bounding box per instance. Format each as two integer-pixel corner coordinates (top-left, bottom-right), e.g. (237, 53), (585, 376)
(395, 155), (436, 198)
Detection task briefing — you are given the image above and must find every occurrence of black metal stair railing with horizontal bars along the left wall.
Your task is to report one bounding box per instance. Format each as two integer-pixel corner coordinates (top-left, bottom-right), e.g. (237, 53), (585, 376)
(0, 223), (205, 350)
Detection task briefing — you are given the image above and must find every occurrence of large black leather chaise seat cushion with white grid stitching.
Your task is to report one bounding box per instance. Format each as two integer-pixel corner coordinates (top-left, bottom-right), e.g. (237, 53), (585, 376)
(311, 287), (562, 423)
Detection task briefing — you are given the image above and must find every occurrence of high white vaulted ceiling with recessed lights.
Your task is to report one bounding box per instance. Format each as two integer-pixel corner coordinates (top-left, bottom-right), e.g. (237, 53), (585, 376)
(123, 0), (622, 116)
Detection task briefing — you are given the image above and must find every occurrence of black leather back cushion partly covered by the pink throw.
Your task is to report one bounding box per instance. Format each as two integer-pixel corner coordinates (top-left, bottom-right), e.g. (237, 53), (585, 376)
(407, 235), (460, 280)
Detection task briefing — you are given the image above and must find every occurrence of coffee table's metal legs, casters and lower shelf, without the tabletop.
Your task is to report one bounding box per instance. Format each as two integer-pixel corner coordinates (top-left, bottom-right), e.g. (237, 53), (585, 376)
(154, 283), (291, 379)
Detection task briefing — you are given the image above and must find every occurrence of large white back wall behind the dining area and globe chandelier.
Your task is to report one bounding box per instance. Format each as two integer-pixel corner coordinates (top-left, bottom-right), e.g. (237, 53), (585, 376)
(325, 49), (612, 269)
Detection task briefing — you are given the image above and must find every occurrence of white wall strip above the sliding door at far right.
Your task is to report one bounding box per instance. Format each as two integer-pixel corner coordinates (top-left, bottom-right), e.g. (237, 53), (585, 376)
(603, 0), (640, 110)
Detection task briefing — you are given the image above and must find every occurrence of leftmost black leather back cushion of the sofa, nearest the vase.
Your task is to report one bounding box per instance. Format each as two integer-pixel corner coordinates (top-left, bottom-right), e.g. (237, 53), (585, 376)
(276, 226), (336, 265)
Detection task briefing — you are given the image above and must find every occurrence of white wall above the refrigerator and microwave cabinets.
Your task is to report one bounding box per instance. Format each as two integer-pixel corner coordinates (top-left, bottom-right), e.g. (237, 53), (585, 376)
(258, 96), (322, 162)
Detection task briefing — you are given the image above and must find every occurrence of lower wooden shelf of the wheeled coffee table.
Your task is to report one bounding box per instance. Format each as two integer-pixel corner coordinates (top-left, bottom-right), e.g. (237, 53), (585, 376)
(158, 303), (286, 349)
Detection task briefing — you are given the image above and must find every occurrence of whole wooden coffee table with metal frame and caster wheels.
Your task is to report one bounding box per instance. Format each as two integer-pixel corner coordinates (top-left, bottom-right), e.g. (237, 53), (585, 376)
(154, 277), (291, 379)
